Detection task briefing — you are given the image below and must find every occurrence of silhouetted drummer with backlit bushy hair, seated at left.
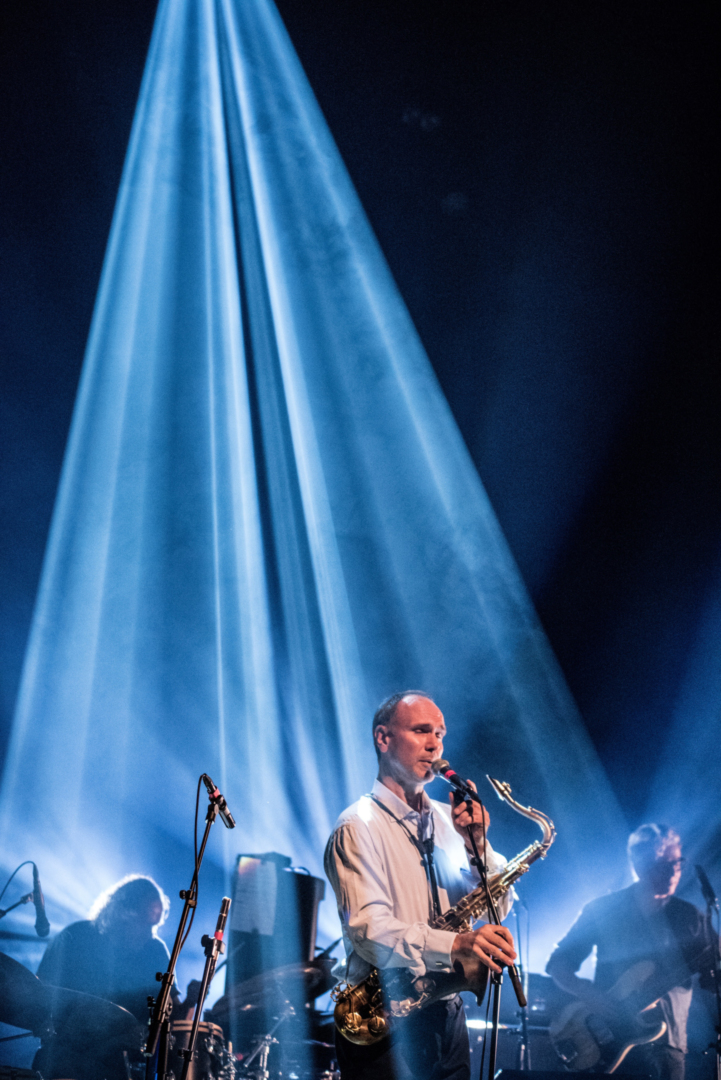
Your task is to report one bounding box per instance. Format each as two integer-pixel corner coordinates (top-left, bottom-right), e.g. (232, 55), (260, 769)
(38, 874), (178, 1022)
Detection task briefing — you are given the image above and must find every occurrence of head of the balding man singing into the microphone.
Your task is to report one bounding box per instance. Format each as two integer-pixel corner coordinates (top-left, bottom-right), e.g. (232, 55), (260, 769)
(376, 696), (446, 787)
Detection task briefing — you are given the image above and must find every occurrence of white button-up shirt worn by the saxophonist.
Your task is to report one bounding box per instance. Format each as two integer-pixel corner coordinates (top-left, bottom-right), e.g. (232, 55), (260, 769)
(325, 780), (512, 985)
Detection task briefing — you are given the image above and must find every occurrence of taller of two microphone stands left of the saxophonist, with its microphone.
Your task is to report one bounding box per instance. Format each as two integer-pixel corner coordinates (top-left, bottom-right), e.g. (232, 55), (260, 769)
(144, 772), (235, 1080)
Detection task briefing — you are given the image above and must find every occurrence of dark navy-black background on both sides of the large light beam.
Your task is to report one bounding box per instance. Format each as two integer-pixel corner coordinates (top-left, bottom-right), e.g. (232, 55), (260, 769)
(0, 0), (721, 826)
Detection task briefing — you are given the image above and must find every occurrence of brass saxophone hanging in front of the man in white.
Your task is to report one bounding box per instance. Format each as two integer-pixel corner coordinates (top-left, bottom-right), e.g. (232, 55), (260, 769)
(331, 777), (556, 1047)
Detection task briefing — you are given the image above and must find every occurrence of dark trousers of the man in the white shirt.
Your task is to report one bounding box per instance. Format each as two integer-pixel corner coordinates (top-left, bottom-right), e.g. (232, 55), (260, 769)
(336, 997), (471, 1080)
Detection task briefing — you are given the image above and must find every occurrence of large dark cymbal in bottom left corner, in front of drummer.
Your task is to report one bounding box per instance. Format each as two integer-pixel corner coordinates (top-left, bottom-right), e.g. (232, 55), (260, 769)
(0, 953), (142, 1045)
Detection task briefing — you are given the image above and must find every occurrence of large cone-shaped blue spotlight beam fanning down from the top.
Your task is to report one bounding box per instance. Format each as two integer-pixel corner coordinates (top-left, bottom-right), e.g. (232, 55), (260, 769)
(0, 0), (624, 972)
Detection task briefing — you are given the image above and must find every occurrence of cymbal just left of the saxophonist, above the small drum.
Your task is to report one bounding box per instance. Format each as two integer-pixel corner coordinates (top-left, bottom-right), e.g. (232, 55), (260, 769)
(210, 959), (336, 1023)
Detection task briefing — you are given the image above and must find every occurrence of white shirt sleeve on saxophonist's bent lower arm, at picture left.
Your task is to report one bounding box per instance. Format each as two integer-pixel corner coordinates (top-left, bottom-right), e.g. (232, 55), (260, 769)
(325, 822), (455, 975)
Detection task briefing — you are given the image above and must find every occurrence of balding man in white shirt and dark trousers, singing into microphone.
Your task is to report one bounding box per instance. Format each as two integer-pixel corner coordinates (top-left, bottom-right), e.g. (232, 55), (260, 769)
(325, 691), (516, 1080)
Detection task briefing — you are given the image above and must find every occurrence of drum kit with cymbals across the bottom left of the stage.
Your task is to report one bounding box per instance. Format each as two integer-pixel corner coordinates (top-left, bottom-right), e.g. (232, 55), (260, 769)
(0, 954), (340, 1080)
